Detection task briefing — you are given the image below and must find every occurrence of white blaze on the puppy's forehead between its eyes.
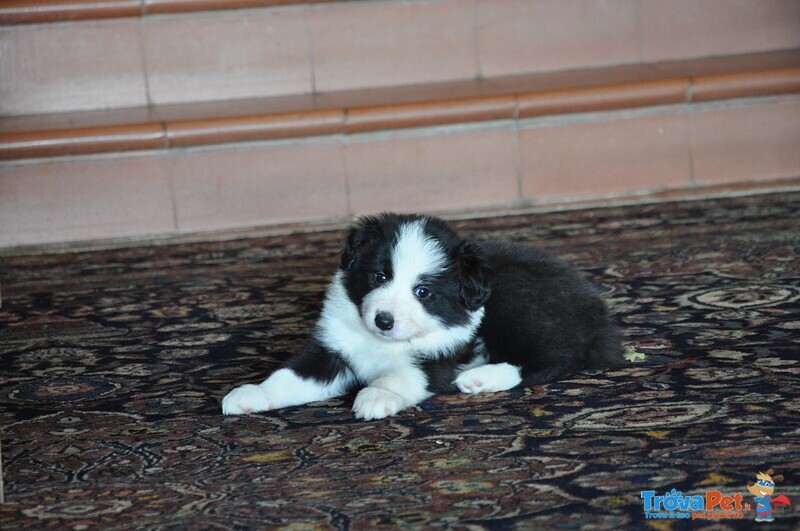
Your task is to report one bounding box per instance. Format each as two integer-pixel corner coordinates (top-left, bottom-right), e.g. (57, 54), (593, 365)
(392, 219), (447, 285)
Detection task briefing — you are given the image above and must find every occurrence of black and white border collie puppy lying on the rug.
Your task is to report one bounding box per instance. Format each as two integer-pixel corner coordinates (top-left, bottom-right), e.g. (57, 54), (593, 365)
(222, 214), (623, 420)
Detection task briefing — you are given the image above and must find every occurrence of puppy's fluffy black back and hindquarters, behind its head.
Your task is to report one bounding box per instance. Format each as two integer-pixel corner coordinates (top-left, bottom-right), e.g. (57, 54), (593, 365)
(478, 243), (622, 385)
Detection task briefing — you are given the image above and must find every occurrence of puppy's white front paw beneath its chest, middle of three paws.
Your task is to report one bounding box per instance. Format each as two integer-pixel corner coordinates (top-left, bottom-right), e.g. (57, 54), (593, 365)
(353, 366), (433, 420)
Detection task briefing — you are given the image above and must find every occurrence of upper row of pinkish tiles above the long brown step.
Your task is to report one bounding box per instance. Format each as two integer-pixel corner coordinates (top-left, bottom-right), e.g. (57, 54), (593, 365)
(0, 0), (800, 115)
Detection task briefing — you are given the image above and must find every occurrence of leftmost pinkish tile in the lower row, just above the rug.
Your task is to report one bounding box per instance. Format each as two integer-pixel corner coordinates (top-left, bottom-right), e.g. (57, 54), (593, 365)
(0, 159), (174, 246)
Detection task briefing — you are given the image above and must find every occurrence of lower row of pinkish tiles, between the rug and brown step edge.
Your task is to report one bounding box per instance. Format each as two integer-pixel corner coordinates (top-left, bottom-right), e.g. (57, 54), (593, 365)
(0, 96), (800, 246)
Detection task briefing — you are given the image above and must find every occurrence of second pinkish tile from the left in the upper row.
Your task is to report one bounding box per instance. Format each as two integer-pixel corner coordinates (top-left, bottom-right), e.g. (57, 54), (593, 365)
(142, 10), (312, 104)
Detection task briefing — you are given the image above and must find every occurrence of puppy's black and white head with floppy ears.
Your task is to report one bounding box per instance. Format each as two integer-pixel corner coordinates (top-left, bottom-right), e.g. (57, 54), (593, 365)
(341, 214), (490, 341)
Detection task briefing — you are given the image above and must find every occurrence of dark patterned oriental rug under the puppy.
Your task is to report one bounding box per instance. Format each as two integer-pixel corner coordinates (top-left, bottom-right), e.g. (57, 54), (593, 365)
(0, 193), (800, 529)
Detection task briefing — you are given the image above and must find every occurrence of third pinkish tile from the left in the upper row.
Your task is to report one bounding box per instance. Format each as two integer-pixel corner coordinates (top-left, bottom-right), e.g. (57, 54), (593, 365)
(313, 0), (478, 91)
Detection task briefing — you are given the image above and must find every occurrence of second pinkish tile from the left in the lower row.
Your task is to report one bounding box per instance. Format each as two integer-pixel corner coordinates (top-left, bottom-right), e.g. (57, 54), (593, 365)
(171, 141), (348, 232)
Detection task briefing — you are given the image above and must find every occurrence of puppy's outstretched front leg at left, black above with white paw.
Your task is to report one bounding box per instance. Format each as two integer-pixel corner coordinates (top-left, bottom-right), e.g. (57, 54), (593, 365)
(222, 345), (355, 415)
